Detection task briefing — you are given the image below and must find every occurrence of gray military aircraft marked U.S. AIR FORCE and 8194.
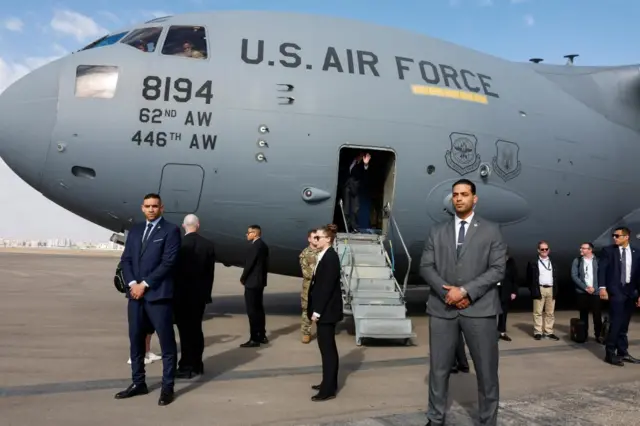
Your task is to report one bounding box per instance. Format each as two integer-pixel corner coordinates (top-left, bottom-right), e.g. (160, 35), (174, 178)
(0, 12), (640, 302)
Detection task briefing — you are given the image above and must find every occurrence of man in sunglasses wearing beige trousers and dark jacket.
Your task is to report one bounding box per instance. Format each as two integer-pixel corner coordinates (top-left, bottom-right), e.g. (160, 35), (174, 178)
(527, 241), (559, 340)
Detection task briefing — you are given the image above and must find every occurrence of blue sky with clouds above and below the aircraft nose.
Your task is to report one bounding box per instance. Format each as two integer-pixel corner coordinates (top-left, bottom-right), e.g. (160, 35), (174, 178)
(0, 0), (640, 240)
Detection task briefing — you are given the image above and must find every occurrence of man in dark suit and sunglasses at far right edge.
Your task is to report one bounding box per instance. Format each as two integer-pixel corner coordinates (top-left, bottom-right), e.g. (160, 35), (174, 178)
(598, 227), (640, 367)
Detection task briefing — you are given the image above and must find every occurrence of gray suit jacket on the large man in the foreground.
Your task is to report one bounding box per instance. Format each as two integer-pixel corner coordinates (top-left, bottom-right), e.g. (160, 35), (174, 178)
(420, 214), (507, 318)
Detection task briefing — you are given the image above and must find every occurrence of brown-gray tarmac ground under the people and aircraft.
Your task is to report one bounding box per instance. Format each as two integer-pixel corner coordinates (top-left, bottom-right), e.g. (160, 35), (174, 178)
(0, 249), (640, 426)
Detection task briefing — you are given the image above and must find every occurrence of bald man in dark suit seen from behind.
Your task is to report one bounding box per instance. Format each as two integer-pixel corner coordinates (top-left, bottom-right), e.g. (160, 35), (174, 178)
(174, 214), (216, 379)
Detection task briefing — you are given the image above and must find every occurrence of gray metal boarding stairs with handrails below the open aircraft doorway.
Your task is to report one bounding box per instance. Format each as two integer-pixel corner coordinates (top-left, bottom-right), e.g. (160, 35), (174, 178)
(334, 200), (415, 346)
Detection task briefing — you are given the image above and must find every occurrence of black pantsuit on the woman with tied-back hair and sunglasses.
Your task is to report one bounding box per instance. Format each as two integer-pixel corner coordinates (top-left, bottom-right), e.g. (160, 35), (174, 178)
(307, 247), (343, 396)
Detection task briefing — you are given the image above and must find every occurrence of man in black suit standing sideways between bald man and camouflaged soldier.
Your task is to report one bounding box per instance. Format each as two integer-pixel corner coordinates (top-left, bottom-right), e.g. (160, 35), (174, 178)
(240, 225), (269, 348)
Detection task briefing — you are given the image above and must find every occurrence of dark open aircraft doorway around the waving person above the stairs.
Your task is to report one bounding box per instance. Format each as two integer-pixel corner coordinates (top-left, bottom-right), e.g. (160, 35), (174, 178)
(333, 146), (396, 235)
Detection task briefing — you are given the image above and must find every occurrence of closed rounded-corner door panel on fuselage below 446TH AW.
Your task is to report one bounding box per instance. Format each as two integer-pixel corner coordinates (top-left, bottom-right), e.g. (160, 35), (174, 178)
(158, 163), (204, 214)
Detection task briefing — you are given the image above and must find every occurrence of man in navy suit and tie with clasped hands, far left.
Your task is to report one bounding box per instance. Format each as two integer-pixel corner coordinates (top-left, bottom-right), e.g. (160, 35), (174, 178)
(115, 194), (181, 405)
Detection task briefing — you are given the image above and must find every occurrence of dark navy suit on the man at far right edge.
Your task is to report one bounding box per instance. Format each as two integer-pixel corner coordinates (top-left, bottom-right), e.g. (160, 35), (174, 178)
(598, 245), (640, 357)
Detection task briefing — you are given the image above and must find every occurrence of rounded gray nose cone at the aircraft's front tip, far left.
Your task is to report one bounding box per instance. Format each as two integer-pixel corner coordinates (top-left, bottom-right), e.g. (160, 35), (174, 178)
(0, 59), (60, 189)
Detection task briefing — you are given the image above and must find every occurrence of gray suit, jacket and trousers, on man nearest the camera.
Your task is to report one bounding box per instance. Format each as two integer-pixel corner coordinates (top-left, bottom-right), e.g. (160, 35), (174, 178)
(420, 214), (507, 426)
